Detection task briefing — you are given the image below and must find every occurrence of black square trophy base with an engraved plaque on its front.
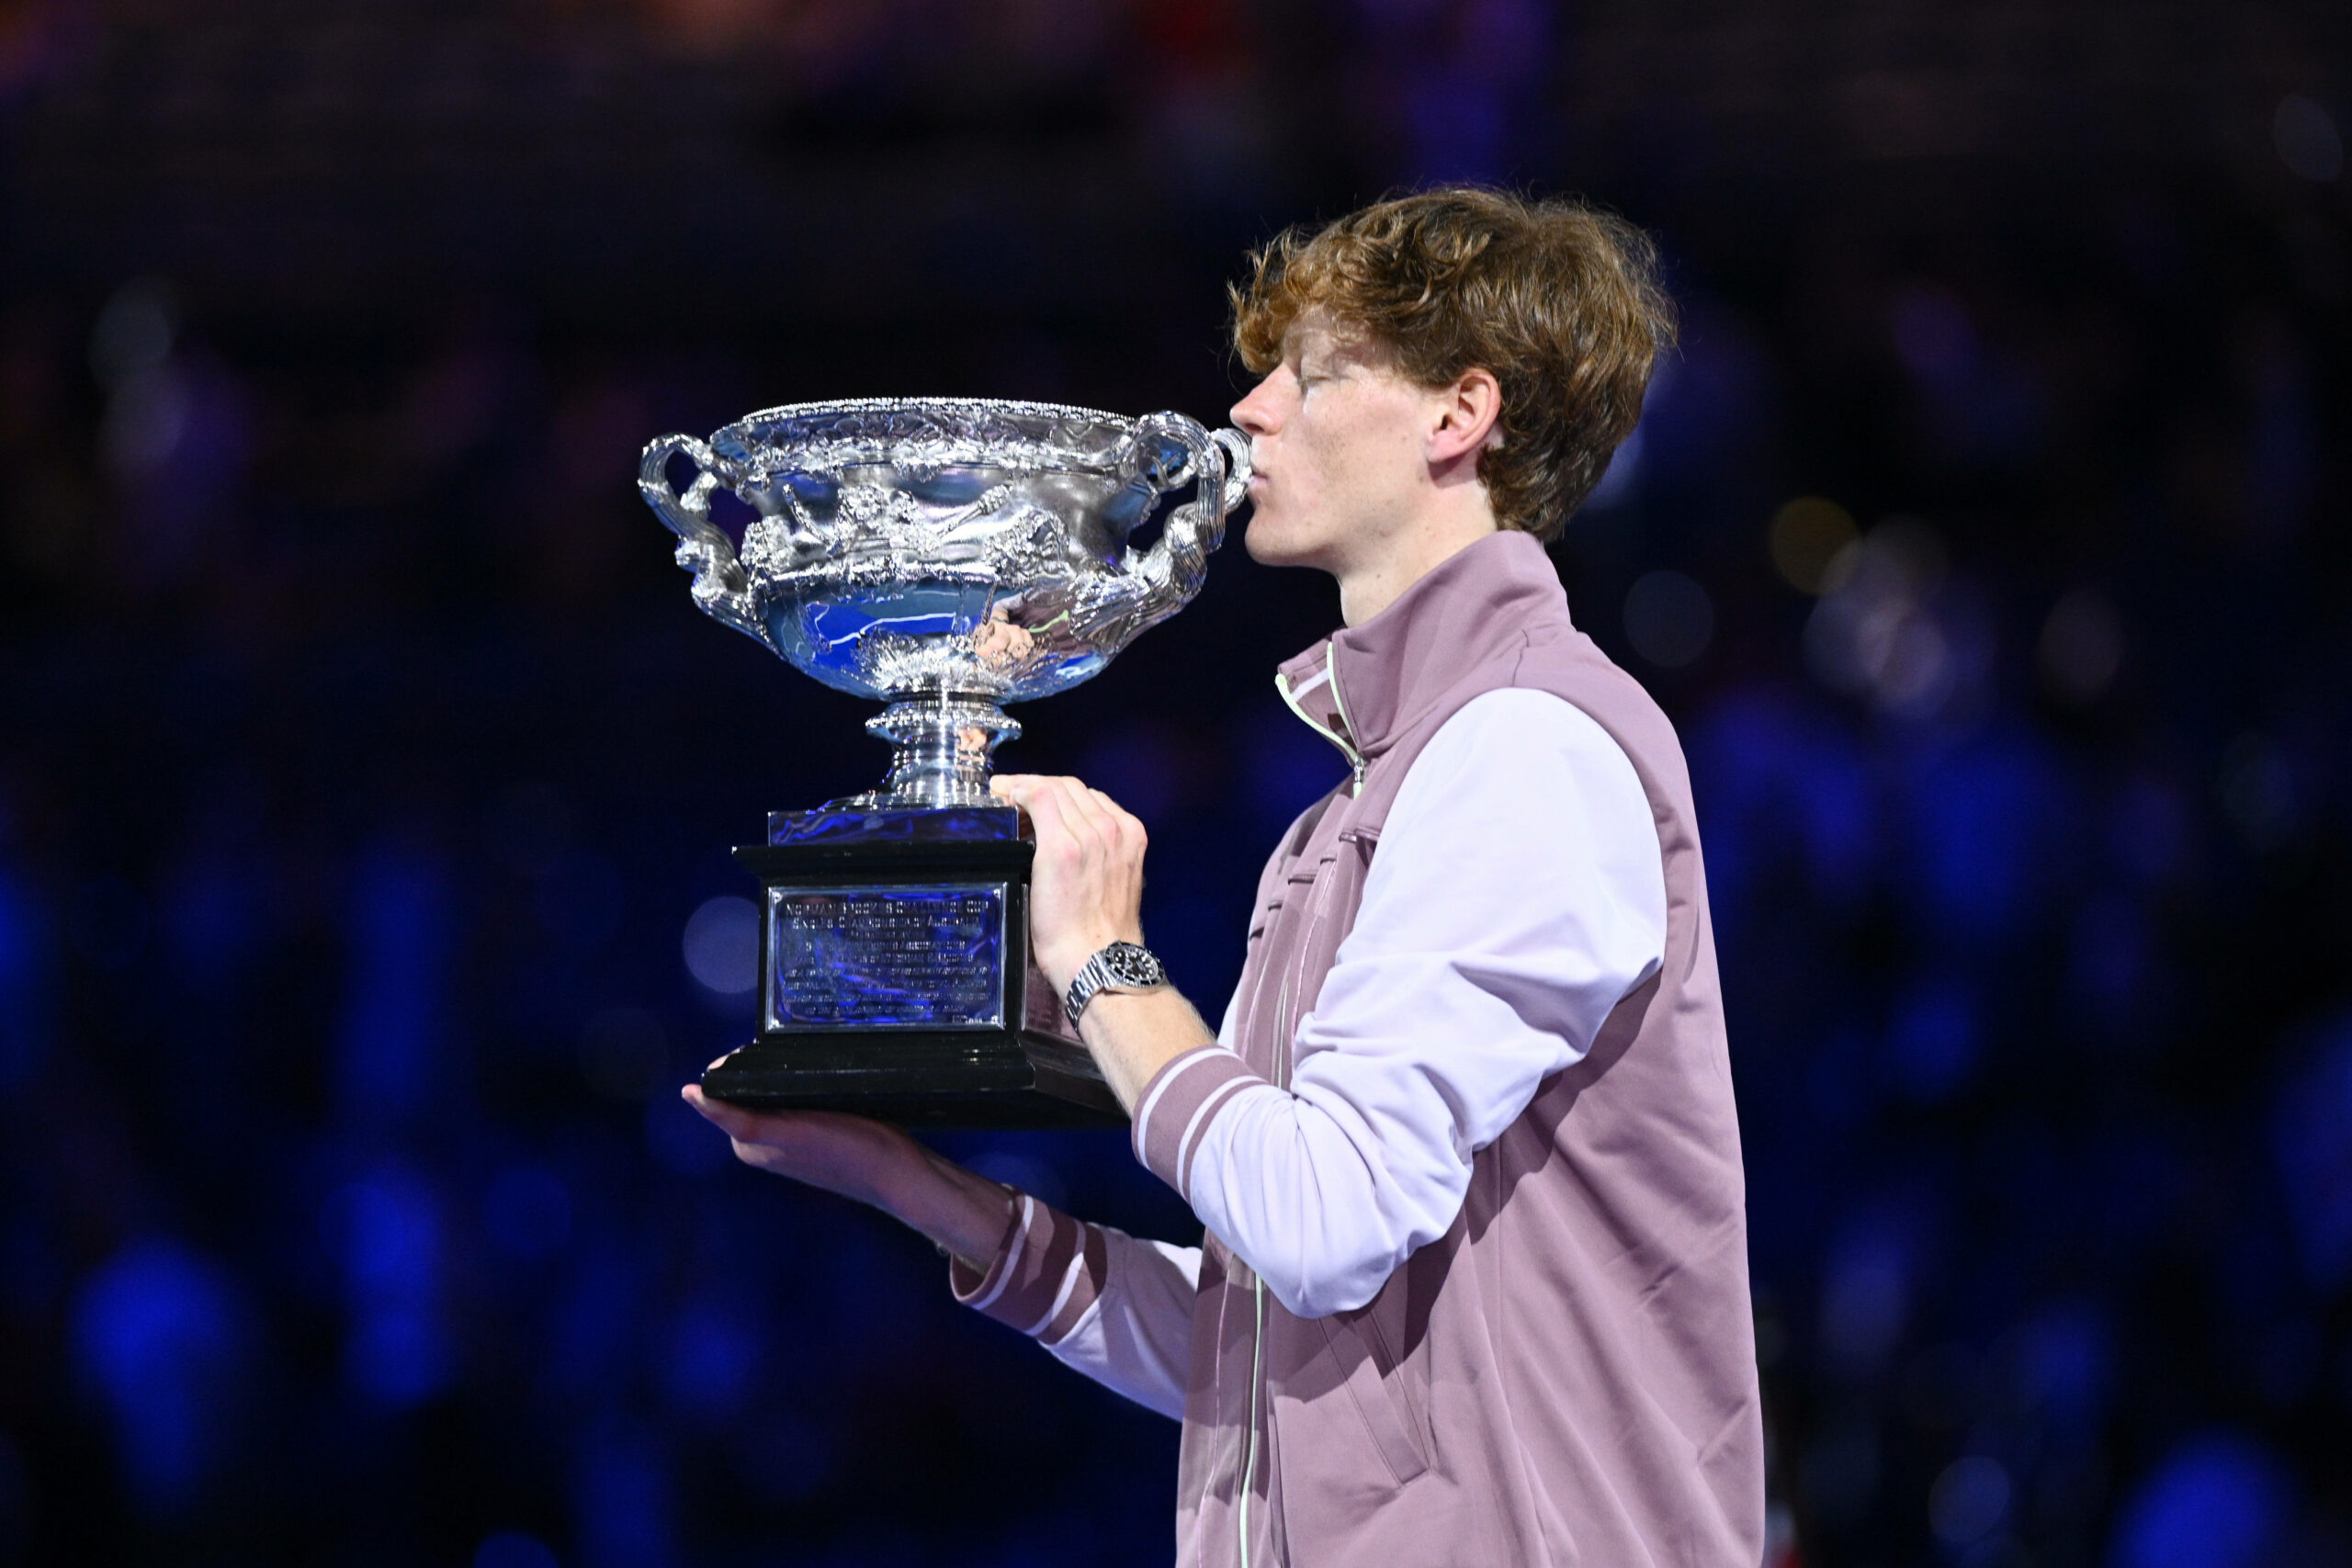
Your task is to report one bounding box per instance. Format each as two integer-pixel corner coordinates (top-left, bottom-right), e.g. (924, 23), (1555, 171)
(703, 802), (1126, 1128)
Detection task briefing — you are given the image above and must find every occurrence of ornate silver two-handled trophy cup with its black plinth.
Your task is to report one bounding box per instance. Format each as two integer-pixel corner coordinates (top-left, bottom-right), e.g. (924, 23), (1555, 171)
(638, 398), (1249, 1126)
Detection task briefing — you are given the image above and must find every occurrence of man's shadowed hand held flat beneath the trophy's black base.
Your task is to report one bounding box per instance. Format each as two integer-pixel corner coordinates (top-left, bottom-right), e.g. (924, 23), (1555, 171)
(680, 1084), (1013, 1272)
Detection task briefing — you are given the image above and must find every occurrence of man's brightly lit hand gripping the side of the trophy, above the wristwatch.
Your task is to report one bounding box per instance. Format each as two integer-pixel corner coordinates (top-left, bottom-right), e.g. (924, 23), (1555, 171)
(988, 773), (1143, 992)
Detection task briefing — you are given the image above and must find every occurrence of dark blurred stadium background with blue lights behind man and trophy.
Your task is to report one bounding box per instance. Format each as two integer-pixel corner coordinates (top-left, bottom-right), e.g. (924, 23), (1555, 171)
(0, 0), (2352, 1568)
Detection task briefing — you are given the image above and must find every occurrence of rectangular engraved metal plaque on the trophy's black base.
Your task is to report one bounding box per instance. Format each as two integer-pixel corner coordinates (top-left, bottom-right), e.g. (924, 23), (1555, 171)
(767, 882), (1004, 1030)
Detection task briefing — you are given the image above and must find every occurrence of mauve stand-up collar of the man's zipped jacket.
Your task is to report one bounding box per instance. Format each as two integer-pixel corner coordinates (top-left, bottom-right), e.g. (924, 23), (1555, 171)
(1275, 529), (1569, 776)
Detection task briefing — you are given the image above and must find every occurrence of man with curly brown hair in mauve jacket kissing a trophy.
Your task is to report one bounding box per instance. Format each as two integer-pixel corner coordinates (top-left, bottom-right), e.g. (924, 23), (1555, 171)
(687, 188), (1764, 1568)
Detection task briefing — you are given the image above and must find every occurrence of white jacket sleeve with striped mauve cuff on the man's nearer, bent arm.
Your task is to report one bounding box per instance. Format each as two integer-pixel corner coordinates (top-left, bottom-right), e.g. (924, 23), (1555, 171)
(1136, 689), (1665, 1316)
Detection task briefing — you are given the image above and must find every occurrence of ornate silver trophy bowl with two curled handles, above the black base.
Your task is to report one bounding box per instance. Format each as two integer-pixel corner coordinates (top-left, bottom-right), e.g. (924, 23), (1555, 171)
(638, 398), (1249, 807)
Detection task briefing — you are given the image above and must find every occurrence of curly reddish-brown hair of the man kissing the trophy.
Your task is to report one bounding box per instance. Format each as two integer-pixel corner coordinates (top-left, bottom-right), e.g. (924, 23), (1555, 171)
(1227, 186), (1675, 541)
